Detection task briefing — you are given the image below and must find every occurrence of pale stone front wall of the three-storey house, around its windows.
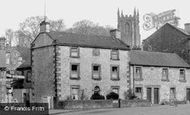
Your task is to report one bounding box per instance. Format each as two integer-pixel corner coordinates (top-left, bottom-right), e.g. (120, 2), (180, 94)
(58, 46), (129, 100)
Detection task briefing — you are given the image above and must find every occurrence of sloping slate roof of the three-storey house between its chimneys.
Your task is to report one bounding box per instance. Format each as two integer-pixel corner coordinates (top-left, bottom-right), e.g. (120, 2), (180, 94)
(49, 32), (129, 50)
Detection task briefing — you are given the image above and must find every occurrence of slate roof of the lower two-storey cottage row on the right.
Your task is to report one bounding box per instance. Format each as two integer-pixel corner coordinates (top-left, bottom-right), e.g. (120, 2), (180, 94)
(129, 50), (190, 68)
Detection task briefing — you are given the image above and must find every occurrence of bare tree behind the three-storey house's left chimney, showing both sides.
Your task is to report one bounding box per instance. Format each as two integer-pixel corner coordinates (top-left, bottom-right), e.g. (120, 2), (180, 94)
(15, 16), (65, 47)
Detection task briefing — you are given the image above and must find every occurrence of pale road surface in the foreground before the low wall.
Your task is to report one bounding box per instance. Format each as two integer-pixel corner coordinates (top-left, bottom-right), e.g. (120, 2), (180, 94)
(49, 104), (190, 115)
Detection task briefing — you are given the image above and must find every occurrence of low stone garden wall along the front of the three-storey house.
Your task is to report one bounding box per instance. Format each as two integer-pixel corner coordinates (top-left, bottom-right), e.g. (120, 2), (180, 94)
(56, 100), (151, 110)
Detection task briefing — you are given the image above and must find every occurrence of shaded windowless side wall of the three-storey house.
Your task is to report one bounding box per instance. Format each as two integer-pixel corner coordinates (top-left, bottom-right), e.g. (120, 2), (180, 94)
(32, 46), (55, 102)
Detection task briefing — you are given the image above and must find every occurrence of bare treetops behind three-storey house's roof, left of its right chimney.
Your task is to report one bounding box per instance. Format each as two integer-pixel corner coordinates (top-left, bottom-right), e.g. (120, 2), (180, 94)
(67, 20), (111, 36)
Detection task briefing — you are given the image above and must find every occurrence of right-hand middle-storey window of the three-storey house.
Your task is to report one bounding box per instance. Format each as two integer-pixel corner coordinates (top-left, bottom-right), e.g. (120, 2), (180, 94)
(111, 66), (119, 80)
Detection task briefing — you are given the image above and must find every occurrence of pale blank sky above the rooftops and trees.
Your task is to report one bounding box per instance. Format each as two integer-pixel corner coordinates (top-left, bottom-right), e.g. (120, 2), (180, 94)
(0, 0), (190, 40)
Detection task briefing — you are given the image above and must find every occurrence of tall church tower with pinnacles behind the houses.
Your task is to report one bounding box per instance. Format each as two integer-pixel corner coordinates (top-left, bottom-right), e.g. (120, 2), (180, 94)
(117, 9), (141, 49)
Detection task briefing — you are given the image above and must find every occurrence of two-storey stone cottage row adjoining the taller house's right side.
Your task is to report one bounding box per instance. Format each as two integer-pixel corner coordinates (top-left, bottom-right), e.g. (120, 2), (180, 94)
(129, 51), (190, 104)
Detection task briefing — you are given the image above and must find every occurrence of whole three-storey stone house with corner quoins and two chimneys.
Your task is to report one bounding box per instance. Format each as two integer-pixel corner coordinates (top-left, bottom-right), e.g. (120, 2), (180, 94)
(31, 21), (129, 101)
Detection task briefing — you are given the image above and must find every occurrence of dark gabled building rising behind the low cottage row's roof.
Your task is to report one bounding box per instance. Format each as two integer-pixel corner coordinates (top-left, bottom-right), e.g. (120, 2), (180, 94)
(143, 23), (190, 64)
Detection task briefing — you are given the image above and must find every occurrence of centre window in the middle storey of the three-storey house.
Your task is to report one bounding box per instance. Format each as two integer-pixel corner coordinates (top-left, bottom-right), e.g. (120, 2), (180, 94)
(92, 64), (101, 80)
